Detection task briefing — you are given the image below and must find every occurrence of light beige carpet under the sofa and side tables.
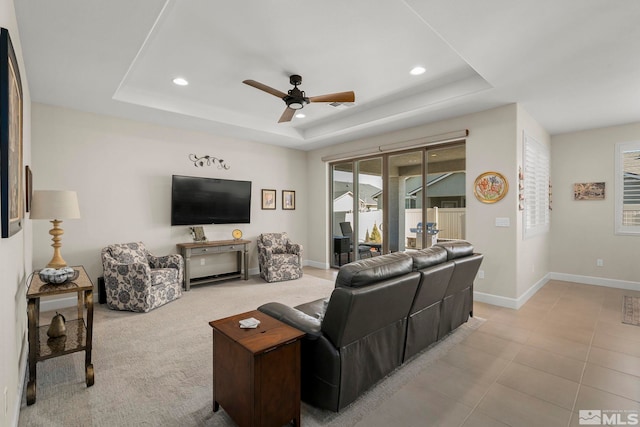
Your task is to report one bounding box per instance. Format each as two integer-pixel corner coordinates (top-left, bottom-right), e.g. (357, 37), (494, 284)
(19, 274), (482, 427)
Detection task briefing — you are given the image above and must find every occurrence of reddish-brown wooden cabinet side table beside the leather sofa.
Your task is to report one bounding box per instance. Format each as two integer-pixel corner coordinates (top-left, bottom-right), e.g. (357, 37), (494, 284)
(209, 311), (305, 427)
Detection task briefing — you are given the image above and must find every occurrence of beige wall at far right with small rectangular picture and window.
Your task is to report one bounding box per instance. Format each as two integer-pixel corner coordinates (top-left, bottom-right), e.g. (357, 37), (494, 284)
(550, 123), (640, 290)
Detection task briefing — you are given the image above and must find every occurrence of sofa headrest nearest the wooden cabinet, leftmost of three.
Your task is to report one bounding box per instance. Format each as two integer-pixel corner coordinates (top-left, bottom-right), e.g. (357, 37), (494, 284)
(336, 252), (413, 288)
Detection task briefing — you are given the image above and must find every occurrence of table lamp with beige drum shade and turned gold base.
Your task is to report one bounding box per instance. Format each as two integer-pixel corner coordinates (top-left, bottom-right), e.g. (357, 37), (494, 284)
(30, 190), (80, 268)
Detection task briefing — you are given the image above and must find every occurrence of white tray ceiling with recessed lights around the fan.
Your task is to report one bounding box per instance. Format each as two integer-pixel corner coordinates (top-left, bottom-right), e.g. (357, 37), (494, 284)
(15, 0), (640, 150)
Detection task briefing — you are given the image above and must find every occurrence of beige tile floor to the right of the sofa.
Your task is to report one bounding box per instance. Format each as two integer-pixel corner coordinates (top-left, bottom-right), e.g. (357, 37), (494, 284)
(308, 270), (640, 427)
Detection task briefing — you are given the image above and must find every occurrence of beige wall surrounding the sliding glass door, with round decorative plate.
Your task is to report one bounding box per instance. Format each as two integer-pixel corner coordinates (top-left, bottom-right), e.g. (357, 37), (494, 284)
(307, 104), (547, 305)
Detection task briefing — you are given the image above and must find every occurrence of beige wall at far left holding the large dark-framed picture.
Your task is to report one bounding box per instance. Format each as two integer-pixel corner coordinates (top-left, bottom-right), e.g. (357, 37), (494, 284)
(0, 0), (32, 426)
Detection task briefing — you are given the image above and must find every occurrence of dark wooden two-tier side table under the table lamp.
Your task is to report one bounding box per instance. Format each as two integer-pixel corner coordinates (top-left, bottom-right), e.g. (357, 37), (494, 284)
(27, 266), (94, 405)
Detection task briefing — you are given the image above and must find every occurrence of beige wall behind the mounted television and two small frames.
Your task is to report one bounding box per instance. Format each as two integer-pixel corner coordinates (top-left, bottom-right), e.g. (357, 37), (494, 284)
(33, 103), (308, 280)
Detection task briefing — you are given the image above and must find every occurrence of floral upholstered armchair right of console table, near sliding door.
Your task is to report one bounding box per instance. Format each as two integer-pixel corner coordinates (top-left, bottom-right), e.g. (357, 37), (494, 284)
(258, 233), (302, 282)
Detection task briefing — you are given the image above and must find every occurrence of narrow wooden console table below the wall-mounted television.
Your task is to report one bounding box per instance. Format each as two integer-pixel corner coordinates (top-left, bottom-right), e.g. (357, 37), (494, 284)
(176, 239), (251, 291)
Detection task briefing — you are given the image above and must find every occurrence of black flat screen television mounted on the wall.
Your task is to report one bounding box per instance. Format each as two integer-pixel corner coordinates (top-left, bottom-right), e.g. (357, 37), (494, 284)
(171, 175), (251, 225)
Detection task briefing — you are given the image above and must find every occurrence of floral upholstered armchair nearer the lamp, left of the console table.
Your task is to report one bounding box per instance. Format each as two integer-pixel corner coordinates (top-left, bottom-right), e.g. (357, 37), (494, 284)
(102, 242), (184, 312)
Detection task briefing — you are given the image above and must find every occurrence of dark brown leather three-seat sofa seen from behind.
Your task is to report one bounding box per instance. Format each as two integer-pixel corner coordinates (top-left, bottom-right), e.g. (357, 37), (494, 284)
(258, 241), (482, 412)
